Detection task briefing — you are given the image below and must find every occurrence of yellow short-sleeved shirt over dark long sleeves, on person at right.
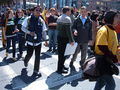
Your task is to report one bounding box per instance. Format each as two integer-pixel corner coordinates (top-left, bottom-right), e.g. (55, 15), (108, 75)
(95, 25), (118, 55)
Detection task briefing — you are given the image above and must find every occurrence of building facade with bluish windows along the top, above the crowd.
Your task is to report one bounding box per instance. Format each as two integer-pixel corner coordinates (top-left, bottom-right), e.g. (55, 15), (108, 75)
(1, 0), (120, 11)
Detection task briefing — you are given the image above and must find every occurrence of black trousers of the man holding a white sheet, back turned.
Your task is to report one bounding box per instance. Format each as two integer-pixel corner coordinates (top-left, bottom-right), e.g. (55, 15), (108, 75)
(57, 36), (69, 72)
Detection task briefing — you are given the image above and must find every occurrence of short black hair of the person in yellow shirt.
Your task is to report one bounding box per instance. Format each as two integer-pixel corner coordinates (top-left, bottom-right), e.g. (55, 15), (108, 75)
(104, 11), (117, 24)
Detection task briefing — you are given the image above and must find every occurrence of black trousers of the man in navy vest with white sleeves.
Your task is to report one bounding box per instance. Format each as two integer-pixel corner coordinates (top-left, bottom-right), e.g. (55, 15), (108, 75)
(24, 44), (41, 72)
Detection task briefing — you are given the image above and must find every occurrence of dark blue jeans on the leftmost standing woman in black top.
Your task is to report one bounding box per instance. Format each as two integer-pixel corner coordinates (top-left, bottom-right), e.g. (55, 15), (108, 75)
(6, 36), (16, 58)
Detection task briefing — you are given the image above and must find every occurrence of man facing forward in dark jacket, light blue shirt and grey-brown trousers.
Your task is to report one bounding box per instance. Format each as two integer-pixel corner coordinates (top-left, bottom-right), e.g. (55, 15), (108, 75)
(70, 6), (92, 68)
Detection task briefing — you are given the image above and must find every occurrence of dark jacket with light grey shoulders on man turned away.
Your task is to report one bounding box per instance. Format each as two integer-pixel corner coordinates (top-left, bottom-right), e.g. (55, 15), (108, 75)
(57, 14), (74, 42)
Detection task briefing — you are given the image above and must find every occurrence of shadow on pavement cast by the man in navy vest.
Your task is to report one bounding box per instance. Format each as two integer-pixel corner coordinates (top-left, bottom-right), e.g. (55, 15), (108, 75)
(5, 68), (38, 90)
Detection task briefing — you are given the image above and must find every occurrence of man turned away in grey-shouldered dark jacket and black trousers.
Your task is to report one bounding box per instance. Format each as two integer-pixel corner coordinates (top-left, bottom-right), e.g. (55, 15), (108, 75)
(57, 6), (74, 74)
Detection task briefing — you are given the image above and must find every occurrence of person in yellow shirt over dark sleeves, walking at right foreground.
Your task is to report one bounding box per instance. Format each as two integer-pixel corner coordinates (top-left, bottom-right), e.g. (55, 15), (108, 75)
(94, 11), (118, 90)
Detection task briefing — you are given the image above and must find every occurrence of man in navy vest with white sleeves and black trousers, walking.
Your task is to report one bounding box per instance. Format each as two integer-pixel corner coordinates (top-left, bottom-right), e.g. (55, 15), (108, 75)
(22, 6), (47, 77)
